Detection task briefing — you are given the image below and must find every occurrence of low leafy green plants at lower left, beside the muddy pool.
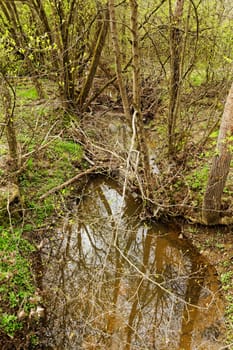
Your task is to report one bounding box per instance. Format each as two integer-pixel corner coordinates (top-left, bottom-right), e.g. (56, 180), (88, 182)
(0, 227), (35, 337)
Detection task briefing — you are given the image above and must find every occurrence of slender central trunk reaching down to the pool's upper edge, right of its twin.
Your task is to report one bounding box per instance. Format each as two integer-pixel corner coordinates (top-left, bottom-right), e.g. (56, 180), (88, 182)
(129, 0), (153, 199)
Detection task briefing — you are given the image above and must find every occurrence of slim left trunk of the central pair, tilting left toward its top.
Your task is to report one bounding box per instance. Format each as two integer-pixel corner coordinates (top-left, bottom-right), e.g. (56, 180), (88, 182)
(109, 0), (131, 125)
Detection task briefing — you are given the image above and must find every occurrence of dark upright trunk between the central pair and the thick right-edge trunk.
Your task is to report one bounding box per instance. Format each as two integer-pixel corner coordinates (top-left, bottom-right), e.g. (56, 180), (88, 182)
(168, 0), (184, 157)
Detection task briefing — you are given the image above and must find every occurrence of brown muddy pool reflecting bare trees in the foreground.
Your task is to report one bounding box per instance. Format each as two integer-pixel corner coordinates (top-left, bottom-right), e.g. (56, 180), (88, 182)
(42, 179), (224, 350)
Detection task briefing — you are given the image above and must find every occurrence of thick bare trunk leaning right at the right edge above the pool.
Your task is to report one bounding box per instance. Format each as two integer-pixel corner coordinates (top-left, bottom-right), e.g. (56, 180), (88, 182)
(202, 84), (233, 225)
